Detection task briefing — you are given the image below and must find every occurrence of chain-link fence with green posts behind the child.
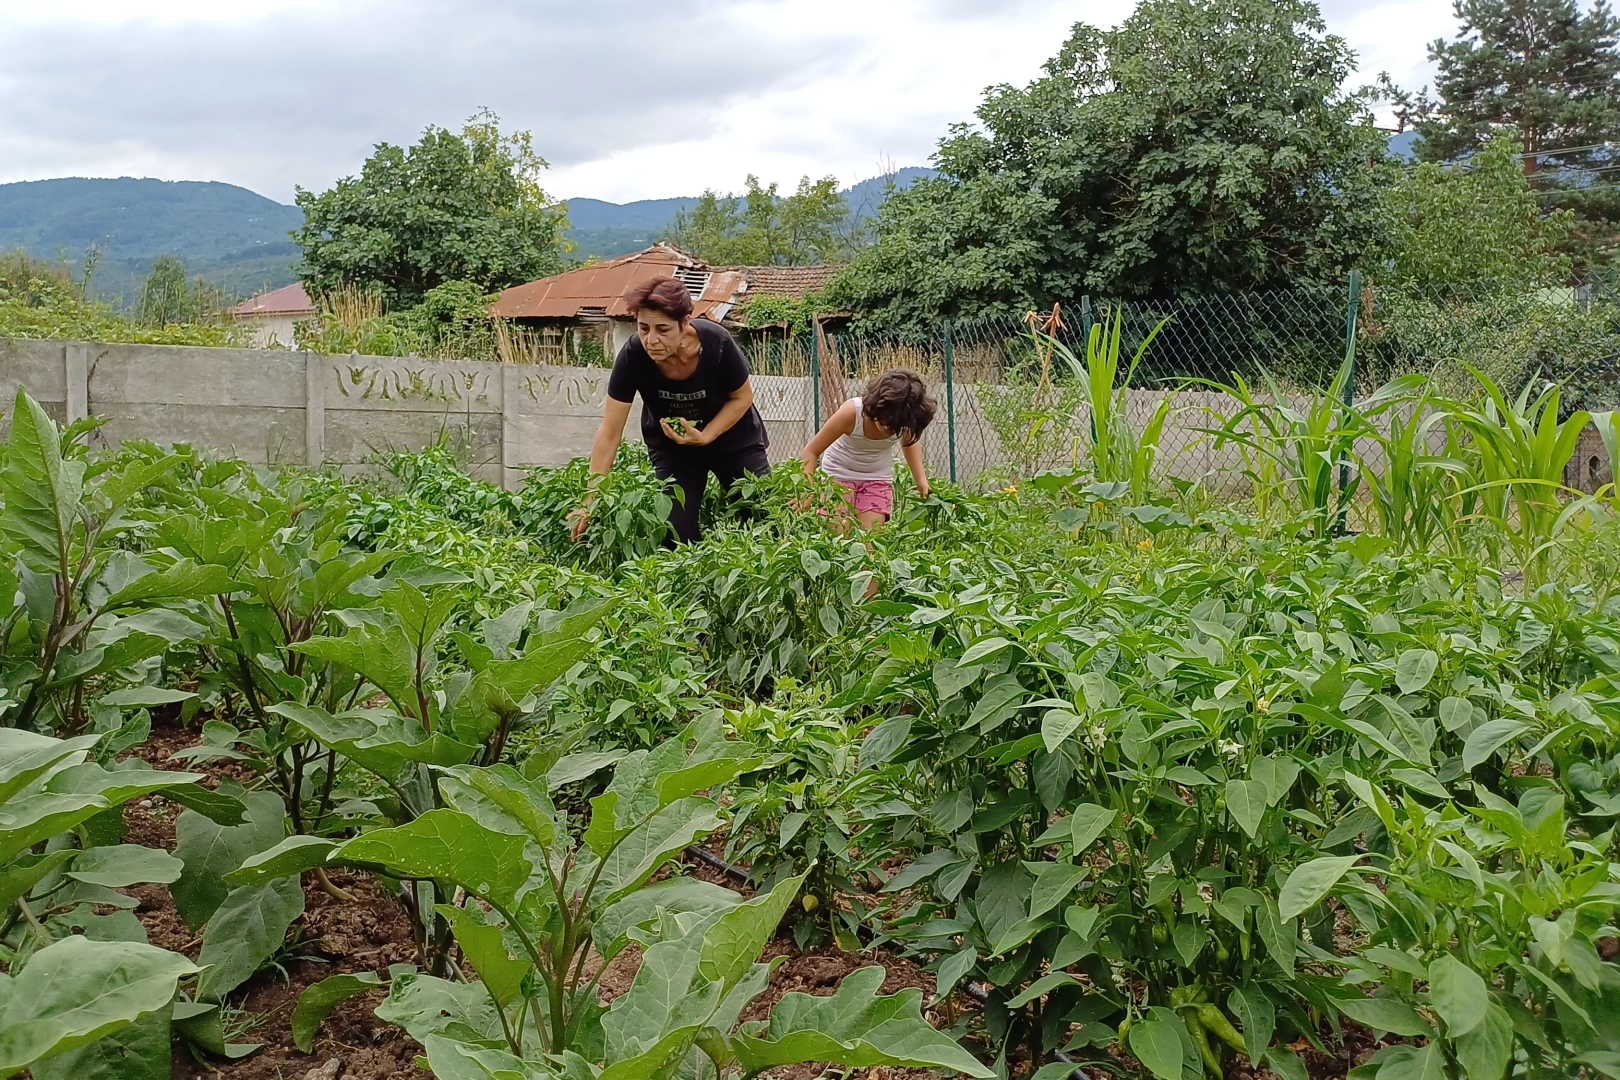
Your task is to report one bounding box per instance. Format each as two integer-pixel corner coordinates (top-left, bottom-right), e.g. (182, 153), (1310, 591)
(744, 275), (1620, 484)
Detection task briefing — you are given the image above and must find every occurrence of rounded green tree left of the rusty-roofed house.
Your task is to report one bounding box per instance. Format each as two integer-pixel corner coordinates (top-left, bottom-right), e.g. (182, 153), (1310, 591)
(293, 110), (569, 306)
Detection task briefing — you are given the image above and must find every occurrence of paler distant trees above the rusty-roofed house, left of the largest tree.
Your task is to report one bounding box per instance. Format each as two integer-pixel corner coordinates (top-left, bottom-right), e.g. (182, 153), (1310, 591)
(669, 173), (849, 266)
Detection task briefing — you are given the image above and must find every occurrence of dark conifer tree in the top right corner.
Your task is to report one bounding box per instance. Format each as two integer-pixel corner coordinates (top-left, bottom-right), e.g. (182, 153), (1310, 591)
(1406, 0), (1620, 267)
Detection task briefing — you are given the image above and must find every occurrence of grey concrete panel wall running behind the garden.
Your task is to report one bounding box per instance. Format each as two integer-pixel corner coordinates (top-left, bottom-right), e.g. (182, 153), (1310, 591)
(0, 340), (1609, 491)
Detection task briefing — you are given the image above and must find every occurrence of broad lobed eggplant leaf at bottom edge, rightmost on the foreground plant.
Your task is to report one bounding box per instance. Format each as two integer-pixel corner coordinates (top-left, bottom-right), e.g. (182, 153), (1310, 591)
(731, 967), (984, 1080)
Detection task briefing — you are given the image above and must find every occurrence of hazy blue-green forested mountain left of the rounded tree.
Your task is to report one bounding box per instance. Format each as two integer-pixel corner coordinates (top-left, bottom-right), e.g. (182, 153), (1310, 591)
(0, 176), (303, 306)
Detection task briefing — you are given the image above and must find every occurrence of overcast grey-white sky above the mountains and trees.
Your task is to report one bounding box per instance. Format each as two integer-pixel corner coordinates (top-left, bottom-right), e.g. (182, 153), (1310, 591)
(0, 0), (1455, 202)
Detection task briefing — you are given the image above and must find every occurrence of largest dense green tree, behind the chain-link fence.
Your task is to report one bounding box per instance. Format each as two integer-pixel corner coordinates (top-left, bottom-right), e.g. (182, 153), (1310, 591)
(822, 0), (1385, 322)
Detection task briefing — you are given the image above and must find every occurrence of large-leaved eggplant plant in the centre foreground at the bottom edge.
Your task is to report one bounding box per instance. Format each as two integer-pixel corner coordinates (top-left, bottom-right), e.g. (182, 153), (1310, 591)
(233, 716), (991, 1078)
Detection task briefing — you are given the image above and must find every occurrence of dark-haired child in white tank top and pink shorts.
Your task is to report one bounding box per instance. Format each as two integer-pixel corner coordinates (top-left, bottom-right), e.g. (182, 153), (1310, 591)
(799, 369), (936, 529)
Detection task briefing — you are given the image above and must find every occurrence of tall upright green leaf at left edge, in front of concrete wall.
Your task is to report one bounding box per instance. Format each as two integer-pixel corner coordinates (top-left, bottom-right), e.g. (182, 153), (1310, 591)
(0, 385), (84, 575)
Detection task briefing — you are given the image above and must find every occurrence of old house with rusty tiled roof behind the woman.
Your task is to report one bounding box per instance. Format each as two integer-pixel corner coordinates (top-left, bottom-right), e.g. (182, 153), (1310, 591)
(489, 244), (838, 363)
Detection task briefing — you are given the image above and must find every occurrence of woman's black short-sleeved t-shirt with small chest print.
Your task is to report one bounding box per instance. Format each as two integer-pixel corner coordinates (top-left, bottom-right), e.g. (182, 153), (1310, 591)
(608, 319), (768, 453)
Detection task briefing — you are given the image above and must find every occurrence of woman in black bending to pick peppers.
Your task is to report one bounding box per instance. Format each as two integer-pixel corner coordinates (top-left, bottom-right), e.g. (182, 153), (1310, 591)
(569, 277), (771, 542)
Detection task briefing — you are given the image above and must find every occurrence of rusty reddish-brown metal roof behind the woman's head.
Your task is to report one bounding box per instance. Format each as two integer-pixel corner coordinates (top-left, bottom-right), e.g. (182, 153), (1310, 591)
(489, 244), (744, 319)
